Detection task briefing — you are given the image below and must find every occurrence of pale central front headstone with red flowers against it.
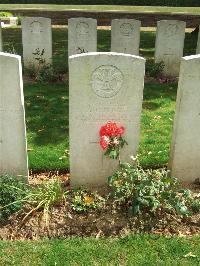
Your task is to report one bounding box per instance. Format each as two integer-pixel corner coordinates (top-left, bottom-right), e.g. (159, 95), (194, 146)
(69, 53), (145, 186)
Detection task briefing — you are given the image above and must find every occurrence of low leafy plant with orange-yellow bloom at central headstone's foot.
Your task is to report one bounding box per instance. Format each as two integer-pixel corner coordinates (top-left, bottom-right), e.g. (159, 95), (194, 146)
(71, 189), (105, 212)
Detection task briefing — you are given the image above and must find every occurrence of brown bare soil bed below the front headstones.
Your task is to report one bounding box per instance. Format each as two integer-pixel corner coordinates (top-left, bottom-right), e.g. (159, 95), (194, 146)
(0, 174), (200, 240)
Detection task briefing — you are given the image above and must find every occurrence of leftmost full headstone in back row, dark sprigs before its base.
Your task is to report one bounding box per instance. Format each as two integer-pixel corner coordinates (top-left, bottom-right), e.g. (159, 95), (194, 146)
(22, 17), (52, 67)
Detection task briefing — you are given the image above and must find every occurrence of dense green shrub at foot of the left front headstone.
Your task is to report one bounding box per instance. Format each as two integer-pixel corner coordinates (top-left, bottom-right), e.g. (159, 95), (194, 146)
(0, 175), (28, 222)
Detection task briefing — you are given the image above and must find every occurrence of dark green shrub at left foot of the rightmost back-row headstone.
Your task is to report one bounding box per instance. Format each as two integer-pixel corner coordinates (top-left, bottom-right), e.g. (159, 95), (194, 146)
(146, 60), (165, 78)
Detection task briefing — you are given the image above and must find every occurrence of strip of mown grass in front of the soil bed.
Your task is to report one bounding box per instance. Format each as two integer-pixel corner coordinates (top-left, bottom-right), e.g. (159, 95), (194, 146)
(0, 235), (200, 266)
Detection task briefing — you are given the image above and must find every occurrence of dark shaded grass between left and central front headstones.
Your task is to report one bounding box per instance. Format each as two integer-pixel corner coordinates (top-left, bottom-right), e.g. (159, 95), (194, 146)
(25, 83), (69, 145)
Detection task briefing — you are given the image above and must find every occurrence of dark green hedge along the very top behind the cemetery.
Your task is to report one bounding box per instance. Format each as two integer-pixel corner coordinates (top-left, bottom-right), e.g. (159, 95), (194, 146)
(0, 0), (200, 6)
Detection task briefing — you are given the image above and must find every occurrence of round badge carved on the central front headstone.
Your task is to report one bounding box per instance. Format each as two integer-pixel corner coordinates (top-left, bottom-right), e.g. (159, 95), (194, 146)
(91, 65), (124, 98)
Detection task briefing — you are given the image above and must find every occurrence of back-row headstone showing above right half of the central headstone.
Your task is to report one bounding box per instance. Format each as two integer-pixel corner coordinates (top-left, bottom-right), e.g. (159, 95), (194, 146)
(111, 19), (141, 55)
